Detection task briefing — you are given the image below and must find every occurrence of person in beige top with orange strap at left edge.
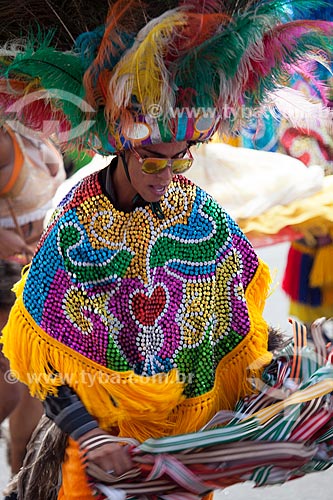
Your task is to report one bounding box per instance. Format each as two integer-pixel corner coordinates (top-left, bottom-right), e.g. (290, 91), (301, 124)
(0, 124), (65, 474)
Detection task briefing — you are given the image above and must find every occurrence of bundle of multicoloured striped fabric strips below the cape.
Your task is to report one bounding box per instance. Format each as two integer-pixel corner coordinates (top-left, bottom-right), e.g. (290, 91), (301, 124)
(83, 318), (333, 500)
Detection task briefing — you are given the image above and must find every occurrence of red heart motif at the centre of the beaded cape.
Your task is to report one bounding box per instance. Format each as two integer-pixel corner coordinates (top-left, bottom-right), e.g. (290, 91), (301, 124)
(132, 286), (167, 326)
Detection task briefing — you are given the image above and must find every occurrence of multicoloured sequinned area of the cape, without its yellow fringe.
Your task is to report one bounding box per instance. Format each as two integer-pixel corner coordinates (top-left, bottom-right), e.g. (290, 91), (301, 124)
(24, 174), (258, 397)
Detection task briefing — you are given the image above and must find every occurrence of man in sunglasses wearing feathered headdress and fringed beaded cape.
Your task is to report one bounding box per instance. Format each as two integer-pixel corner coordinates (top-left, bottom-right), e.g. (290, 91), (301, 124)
(2, 1), (333, 500)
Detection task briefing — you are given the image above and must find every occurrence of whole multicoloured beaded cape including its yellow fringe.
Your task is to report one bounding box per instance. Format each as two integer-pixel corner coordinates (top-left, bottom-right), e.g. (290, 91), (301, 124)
(3, 173), (270, 438)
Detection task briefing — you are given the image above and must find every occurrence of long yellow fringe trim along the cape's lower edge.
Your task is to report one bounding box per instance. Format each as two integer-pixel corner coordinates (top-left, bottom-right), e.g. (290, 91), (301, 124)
(2, 261), (272, 441)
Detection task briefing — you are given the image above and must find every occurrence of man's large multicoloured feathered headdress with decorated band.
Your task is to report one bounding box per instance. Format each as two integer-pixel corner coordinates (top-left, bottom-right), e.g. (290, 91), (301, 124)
(0, 0), (333, 154)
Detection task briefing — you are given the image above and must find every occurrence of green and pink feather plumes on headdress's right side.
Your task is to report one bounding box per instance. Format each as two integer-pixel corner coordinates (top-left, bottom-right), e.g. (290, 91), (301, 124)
(171, 2), (332, 116)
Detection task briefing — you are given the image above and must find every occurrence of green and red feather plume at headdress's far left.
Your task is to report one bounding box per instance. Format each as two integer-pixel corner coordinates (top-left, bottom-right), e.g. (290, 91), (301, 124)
(0, 32), (101, 146)
